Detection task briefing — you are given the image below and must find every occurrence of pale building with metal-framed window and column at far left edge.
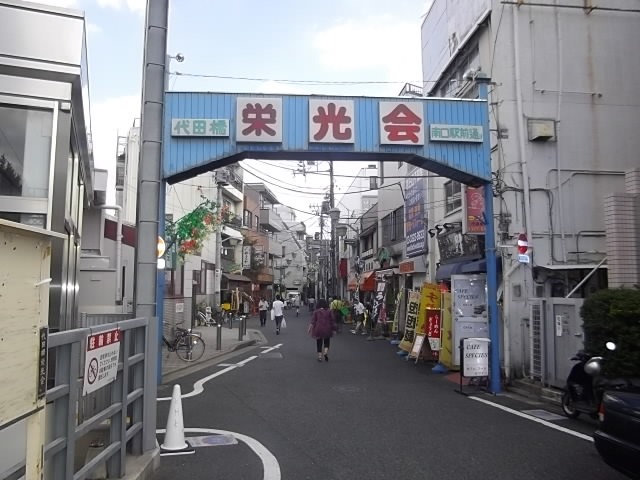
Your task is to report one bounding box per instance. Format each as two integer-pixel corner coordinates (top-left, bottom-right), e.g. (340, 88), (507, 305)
(0, 2), (95, 329)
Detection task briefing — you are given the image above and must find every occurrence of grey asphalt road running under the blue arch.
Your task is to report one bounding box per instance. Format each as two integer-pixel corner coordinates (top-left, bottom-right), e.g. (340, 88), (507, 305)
(155, 313), (624, 480)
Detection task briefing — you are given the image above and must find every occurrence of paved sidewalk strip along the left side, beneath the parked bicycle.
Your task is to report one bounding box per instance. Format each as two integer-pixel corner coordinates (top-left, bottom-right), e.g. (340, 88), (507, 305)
(162, 316), (267, 378)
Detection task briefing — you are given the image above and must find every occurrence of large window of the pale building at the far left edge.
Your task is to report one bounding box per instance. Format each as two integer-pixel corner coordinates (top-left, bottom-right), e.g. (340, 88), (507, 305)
(0, 105), (53, 198)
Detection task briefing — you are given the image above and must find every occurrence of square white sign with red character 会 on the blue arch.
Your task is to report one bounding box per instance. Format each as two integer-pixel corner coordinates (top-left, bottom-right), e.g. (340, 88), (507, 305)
(380, 102), (424, 145)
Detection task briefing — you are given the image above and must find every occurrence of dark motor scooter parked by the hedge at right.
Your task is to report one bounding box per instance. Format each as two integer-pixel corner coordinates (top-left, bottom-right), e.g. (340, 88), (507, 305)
(561, 342), (616, 418)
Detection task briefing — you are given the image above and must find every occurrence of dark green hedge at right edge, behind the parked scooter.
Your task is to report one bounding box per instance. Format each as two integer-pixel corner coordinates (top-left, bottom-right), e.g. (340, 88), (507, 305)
(580, 288), (640, 378)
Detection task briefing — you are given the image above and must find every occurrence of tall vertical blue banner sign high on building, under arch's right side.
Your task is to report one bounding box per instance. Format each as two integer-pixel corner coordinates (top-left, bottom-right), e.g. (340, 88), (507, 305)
(404, 168), (427, 257)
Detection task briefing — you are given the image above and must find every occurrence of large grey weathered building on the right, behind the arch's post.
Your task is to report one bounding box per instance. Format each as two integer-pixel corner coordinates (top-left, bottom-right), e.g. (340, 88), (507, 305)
(422, 0), (640, 377)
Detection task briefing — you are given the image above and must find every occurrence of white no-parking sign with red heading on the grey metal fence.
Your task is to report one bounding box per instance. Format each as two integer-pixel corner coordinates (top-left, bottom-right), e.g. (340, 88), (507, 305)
(82, 328), (121, 395)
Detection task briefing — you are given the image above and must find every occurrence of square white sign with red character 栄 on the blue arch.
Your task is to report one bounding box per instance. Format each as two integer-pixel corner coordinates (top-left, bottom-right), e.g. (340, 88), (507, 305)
(236, 97), (282, 143)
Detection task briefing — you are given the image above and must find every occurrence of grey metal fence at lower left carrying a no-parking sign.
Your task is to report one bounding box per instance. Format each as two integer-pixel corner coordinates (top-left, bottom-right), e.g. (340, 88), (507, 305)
(44, 318), (158, 480)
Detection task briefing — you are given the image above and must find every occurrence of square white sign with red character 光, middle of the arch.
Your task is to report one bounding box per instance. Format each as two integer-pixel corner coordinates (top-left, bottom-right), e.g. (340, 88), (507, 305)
(309, 98), (355, 143)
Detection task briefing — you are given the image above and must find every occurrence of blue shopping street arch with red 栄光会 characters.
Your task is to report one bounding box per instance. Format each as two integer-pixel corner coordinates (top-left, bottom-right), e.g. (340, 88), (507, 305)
(158, 88), (500, 392)
